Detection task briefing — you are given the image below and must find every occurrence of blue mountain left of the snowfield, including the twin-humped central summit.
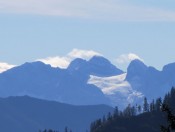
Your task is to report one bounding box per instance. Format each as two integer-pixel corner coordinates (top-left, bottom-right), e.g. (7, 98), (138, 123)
(0, 56), (123, 105)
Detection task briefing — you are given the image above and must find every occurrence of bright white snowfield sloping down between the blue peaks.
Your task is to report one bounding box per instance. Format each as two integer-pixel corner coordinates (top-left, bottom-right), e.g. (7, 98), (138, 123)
(88, 73), (144, 108)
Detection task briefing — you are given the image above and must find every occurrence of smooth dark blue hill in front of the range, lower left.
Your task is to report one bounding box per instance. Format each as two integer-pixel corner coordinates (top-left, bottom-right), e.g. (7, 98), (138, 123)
(0, 96), (113, 132)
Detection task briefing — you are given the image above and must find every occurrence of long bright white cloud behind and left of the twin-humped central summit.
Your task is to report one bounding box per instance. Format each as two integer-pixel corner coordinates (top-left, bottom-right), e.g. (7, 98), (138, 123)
(37, 49), (102, 68)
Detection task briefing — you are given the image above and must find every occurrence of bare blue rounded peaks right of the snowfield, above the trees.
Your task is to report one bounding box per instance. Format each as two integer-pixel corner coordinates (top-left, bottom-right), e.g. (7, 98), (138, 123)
(126, 60), (175, 99)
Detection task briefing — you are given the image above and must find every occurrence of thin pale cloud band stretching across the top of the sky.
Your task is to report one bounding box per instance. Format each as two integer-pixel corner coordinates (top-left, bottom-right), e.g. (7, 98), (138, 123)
(0, 0), (175, 21)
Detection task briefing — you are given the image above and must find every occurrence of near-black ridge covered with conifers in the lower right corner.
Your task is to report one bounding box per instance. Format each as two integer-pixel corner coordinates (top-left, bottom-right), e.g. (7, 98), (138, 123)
(91, 88), (175, 132)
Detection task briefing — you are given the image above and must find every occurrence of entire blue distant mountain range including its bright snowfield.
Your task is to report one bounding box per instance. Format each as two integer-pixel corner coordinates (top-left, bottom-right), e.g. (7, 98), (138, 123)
(0, 56), (175, 108)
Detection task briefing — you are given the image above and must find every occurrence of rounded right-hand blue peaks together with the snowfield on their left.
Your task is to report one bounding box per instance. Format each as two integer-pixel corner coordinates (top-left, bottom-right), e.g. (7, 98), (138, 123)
(88, 60), (175, 109)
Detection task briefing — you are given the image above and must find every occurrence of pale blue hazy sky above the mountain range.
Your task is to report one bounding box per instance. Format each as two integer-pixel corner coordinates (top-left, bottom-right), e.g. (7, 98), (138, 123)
(0, 0), (175, 69)
